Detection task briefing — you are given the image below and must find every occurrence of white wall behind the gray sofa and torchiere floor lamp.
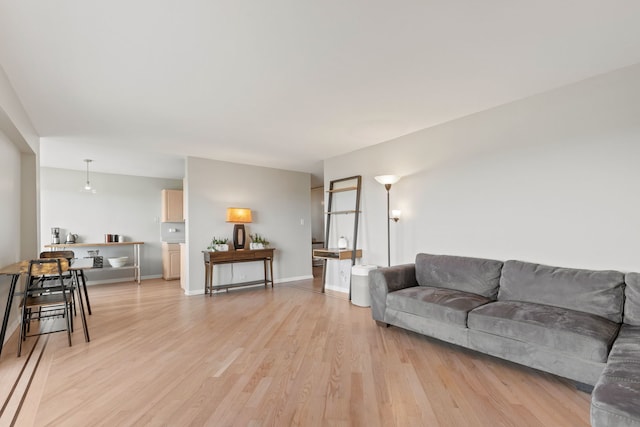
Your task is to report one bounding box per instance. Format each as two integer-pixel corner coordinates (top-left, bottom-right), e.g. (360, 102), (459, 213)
(325, 65), (640, 286)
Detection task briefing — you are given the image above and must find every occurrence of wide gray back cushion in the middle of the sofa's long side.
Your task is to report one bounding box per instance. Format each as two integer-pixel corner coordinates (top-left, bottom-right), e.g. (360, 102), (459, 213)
(498, 261), (624, 323)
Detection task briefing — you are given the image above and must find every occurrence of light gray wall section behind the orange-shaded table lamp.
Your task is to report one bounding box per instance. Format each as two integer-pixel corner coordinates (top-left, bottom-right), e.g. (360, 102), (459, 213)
(185, 157), (312, 294)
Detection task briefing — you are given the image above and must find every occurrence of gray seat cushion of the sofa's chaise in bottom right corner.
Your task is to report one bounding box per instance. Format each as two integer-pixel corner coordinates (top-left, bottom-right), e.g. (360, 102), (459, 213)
(591, 325), (640, 426)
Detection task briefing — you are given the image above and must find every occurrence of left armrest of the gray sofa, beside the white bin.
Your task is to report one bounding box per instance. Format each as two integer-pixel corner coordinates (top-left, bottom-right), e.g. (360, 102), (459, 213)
(369, 264), (418, 322)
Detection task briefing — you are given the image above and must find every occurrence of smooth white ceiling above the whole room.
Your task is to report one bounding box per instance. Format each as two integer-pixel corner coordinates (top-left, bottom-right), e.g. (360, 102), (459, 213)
(0, 0), (640, 183)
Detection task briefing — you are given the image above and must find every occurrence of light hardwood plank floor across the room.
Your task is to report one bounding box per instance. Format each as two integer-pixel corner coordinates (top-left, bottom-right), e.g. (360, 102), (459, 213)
(0, 280), (589, 427)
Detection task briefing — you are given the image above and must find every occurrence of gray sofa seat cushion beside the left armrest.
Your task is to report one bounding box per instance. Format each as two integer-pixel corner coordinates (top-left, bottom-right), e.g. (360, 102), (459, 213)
(387, 286), (491, 327)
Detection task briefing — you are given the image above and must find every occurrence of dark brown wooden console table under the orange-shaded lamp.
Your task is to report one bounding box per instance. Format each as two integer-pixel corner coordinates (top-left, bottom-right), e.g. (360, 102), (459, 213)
(202, 248), (275, 296)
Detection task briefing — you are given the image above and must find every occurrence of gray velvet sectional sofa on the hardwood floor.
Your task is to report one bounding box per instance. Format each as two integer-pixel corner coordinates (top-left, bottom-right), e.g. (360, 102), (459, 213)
(369, 254), (640, 427)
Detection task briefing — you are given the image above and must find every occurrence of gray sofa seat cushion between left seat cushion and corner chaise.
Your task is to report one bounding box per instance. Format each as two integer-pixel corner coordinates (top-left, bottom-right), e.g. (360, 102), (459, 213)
(467, 301), (619, 363)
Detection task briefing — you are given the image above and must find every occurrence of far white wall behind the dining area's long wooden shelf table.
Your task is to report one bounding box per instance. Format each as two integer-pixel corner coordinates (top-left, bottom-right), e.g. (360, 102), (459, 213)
(40, 168), (182, 283)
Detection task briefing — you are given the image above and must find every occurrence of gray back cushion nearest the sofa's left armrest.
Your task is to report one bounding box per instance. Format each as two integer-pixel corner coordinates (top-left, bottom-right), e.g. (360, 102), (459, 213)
(416, 254), (502, 300)
